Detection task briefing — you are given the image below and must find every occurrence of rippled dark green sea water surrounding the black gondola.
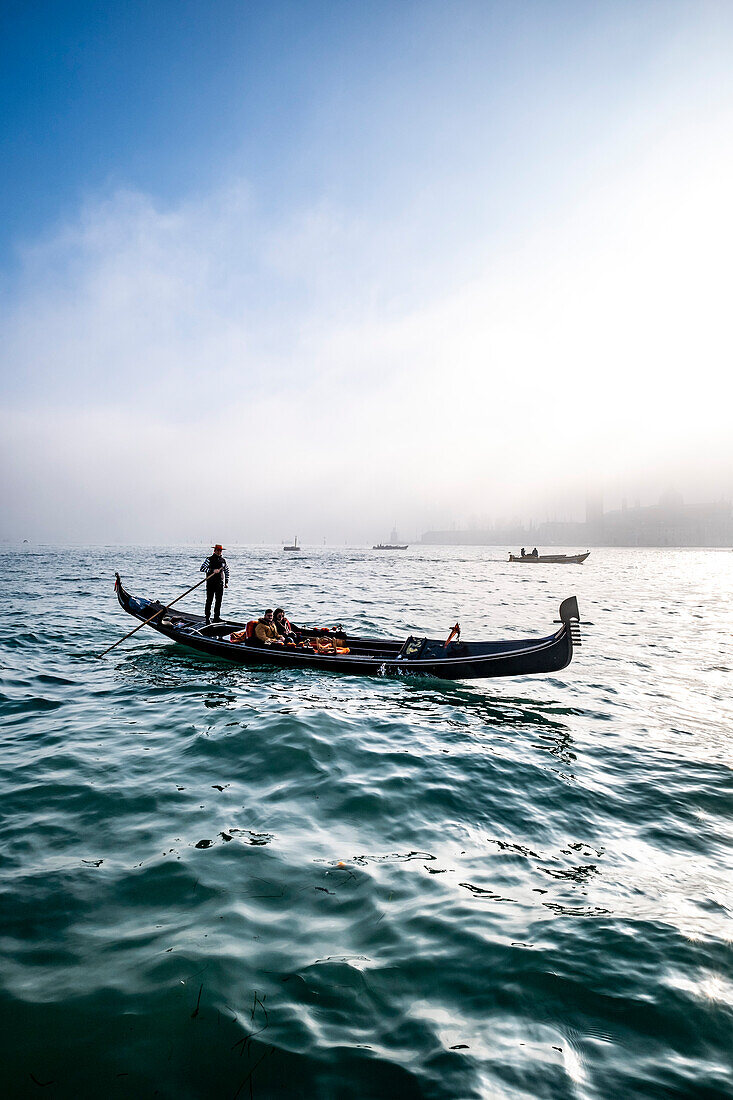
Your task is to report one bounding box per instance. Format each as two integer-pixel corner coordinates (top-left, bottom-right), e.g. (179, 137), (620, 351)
(0, 545), (733, 1100)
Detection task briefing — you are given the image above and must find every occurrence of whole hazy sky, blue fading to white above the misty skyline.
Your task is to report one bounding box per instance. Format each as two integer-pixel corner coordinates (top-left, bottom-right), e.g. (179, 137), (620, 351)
(0, 0), (733, 546)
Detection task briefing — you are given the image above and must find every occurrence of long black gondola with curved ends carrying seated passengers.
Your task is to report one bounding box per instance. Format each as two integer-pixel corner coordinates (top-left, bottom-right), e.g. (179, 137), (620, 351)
(114, 573), (580, 680)
